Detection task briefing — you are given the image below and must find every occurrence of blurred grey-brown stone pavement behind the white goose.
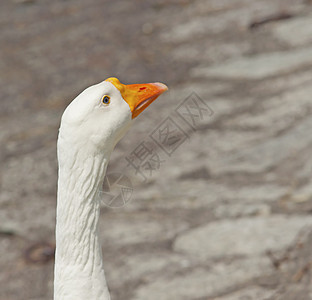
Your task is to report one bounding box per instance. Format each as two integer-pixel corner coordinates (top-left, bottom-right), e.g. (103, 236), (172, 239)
(0, 0), (312, 300)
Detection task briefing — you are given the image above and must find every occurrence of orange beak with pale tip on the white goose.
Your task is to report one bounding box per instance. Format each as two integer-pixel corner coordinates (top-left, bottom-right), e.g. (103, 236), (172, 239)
(105, 77), (168, 119)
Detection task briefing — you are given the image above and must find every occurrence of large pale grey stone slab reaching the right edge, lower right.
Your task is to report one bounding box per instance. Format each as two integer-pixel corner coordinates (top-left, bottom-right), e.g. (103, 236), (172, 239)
(173, 215), (312, 259)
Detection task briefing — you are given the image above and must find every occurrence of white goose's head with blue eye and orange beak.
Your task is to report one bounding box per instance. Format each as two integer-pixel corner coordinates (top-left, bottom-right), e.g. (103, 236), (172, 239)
(59, 77), (168, 152)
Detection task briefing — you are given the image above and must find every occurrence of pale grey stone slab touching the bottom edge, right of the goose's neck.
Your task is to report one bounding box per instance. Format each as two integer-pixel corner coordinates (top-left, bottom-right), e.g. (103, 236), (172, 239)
(133, 257), (272, 300)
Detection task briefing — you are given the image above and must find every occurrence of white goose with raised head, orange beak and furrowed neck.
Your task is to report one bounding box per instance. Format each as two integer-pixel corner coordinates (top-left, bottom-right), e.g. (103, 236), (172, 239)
(54, 78), (167, 300)
